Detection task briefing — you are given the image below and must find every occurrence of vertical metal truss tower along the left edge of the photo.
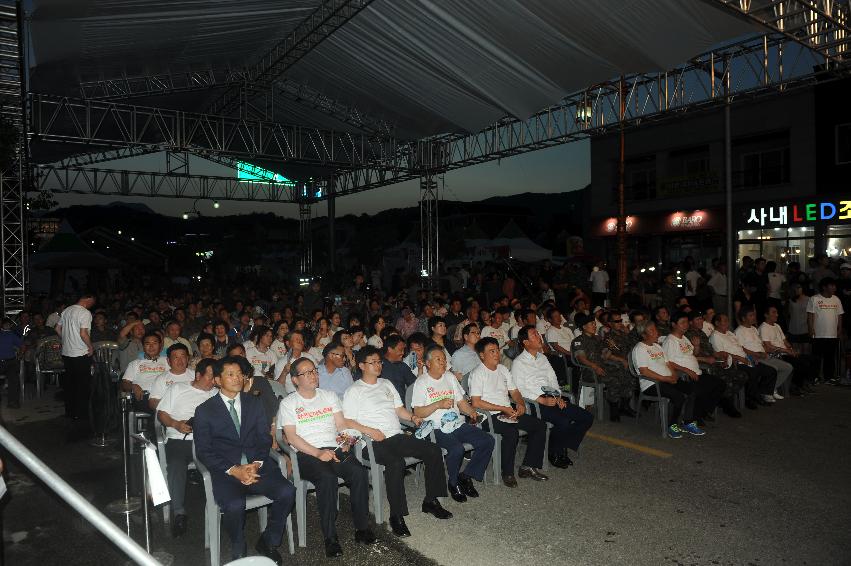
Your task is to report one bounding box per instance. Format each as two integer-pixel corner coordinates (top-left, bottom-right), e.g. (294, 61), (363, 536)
(0, 0), (25, 317)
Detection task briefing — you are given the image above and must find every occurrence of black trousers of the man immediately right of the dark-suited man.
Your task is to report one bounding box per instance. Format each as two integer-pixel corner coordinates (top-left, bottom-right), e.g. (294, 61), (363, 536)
(298, 447), (369, 540)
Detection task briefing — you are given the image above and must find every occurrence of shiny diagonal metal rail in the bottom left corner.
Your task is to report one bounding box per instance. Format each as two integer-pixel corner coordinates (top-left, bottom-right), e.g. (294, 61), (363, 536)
(0, 426), (162, 566)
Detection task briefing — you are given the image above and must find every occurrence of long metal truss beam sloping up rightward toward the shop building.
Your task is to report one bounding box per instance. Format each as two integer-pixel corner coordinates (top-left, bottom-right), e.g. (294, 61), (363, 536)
(336, 35), (837, 196)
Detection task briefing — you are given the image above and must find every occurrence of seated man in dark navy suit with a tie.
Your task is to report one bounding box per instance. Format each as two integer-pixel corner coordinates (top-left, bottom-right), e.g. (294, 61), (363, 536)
(193, 356), (295, 564)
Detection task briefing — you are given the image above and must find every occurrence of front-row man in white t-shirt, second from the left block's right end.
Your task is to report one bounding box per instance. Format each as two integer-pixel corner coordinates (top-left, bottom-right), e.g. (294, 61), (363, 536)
(469, 338), (547, 487)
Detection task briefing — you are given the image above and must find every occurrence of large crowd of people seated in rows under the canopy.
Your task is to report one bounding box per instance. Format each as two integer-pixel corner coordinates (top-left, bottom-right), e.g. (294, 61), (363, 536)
(18, 255), (851, 560)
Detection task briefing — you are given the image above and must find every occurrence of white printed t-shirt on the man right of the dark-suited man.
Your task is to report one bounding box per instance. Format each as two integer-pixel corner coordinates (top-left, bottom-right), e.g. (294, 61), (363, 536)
(278, 389), (343, 448)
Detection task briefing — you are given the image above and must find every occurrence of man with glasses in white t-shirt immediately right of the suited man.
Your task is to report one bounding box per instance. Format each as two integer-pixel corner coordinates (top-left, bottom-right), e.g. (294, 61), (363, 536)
(277, 358), (375, 558)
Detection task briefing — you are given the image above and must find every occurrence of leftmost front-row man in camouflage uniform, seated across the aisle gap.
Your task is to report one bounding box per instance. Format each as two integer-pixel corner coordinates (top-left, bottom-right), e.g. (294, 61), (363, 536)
(570, 315), (635, 422)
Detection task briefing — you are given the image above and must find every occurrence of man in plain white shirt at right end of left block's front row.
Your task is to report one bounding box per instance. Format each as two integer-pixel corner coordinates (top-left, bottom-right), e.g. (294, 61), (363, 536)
(511, 325), (594, 468)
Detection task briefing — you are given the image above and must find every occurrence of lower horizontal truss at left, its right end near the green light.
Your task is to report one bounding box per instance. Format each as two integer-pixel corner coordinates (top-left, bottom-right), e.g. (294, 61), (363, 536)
(33, 165), (316, 203)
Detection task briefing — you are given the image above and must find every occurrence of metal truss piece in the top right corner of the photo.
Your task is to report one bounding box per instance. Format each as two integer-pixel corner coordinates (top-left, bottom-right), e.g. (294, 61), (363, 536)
(705, 0), (851, 63)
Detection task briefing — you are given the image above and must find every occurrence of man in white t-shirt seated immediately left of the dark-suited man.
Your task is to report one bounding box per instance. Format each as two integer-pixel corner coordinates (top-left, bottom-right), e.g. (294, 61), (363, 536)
(157, 358), (217, 537)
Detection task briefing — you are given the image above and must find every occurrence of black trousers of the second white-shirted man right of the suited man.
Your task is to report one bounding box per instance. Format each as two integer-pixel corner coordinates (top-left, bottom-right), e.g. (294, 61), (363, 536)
(364, 434), (448, 517)
